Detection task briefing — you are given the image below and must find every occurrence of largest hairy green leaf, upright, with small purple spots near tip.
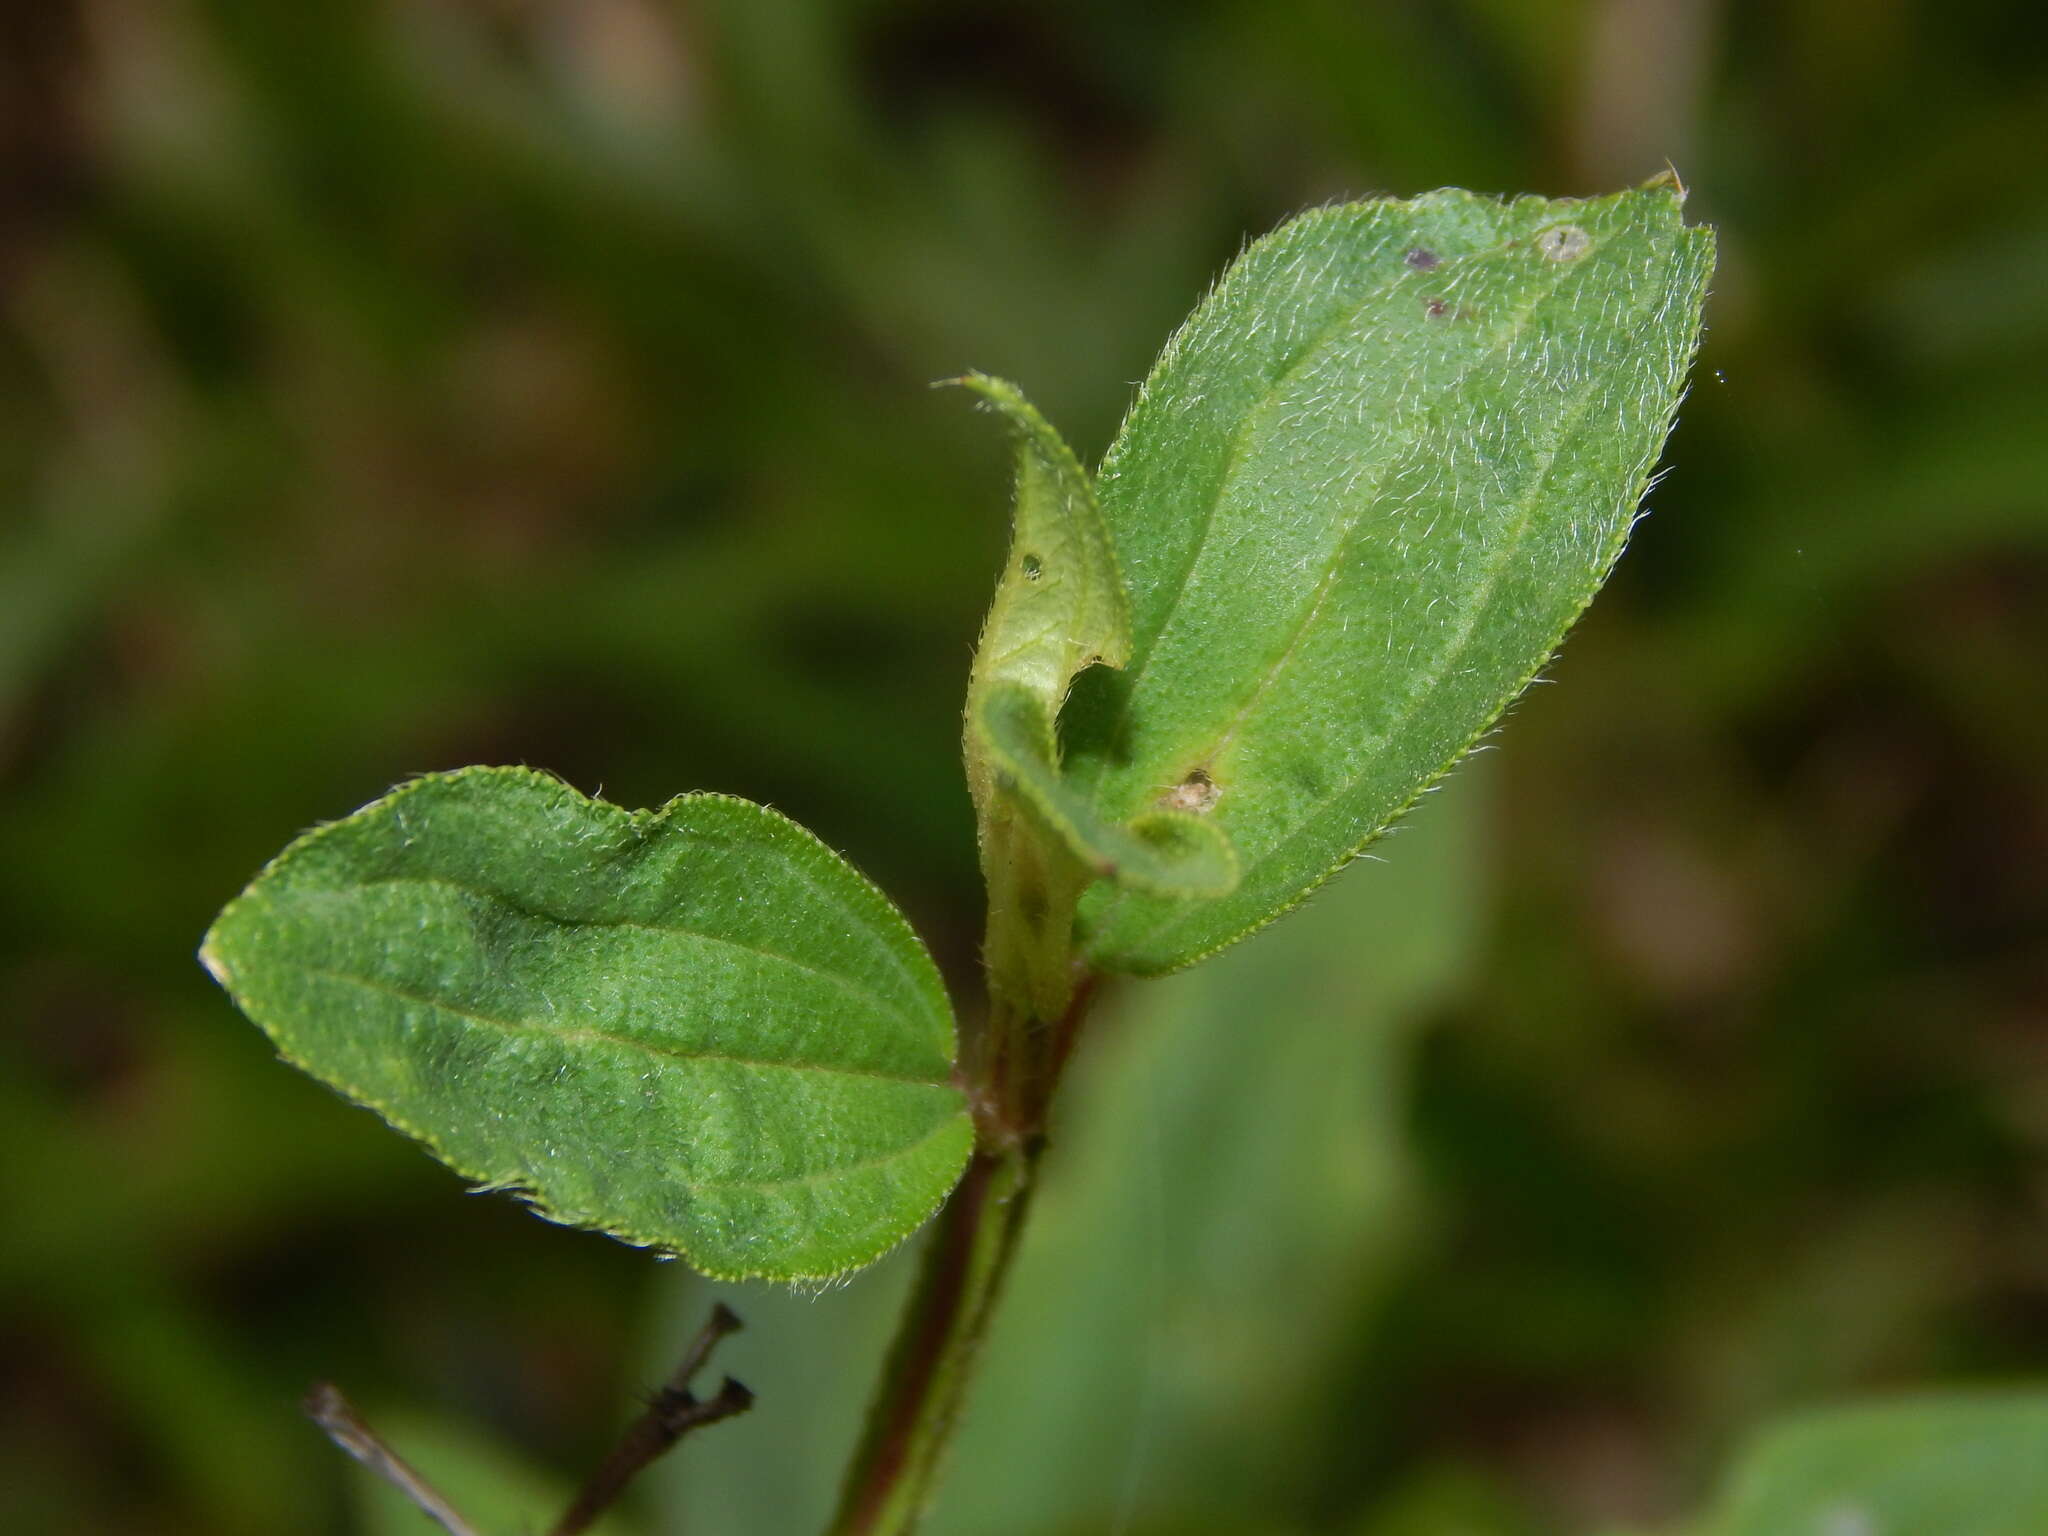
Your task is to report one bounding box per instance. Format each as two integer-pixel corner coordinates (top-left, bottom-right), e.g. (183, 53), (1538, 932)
(1063, 180), (1712, 973)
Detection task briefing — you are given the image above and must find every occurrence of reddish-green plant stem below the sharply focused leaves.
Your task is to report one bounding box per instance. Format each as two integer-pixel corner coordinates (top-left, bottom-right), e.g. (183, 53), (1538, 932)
(827, 981), (1094, 1536)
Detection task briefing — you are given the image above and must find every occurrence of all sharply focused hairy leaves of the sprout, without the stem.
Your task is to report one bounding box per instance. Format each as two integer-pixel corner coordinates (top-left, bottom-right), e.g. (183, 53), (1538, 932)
(201, 180), (1712, 1280)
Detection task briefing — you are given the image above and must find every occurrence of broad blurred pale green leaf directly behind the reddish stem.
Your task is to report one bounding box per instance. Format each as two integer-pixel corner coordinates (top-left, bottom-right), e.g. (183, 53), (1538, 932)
(663, 772), (1493, 1536)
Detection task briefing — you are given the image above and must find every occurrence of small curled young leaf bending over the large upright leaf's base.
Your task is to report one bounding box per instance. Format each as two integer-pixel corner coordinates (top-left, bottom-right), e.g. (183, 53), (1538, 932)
(975, 682), (1237, 897)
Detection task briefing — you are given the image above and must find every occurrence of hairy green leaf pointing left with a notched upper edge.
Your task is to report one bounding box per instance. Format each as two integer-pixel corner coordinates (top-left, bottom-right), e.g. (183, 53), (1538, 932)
(201, 768), (973, 1280)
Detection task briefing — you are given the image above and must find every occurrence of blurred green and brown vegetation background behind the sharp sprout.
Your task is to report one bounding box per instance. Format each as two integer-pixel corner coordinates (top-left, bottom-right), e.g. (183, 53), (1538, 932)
(0, 0), (2048, 1536)
